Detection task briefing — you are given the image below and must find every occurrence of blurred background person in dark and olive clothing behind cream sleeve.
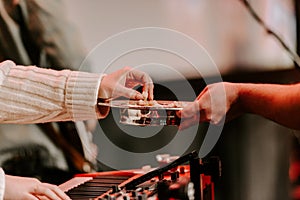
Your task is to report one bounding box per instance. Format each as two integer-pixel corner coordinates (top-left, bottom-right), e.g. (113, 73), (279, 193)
(0, 0), (99, 184)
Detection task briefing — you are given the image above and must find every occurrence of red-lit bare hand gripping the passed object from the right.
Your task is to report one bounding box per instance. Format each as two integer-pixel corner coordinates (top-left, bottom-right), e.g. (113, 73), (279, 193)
(178, 82), (241, 129)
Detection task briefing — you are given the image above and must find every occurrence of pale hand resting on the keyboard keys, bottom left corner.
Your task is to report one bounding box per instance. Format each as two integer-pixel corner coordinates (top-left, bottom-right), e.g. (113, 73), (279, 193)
(4, 175), (71, 200)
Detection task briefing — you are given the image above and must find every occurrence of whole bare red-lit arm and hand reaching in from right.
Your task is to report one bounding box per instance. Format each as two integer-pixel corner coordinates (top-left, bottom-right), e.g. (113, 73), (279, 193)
(178, 82), (300, 130)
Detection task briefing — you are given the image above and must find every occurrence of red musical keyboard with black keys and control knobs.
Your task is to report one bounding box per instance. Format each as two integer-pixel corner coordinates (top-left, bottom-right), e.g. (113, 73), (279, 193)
(59, 152), (220, 200)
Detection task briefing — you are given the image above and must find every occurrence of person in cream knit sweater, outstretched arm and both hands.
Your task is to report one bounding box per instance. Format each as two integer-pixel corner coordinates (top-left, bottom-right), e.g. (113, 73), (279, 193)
(0, 61), (153, 199)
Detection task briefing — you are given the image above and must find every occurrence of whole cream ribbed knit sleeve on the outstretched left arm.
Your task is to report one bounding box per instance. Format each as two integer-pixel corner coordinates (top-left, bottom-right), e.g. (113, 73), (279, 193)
(0, 61), (104, 123)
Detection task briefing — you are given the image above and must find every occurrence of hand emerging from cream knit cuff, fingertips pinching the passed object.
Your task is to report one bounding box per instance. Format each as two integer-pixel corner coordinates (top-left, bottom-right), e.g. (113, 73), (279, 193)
(99, 67), (154, 100)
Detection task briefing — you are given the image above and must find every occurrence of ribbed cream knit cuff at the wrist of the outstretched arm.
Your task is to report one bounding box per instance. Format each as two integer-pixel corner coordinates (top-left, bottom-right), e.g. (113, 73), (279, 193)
(65, 71), (103, 121)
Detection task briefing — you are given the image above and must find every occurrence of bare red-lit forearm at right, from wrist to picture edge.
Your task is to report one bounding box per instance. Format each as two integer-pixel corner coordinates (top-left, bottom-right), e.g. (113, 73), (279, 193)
(238, 83), (300, 129)
